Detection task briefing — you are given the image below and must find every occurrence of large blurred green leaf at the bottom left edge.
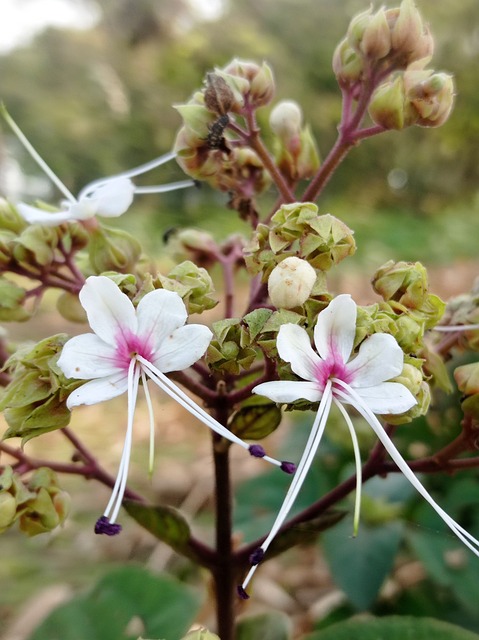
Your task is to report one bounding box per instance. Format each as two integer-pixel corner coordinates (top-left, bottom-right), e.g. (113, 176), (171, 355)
(29, 567), (199, 640)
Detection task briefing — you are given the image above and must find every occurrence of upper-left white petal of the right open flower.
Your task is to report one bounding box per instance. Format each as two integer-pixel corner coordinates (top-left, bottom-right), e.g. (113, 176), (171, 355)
(276, 324), (321, 380)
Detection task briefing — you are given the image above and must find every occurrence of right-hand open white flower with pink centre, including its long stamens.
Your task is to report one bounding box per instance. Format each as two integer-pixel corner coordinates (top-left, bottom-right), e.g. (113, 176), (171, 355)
(238, 295), (479, 598)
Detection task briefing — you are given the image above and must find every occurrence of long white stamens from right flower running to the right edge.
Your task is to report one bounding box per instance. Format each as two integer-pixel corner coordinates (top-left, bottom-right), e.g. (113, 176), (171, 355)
(337, 381), (479, 556)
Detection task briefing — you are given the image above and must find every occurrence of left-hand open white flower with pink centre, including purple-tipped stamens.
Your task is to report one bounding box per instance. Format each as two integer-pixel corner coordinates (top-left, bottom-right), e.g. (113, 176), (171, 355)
(58, 276), (292, 535)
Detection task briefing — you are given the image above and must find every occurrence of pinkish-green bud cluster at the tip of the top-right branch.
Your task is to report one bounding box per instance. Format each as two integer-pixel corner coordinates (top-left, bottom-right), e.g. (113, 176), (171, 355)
(333, 0), (454, 129)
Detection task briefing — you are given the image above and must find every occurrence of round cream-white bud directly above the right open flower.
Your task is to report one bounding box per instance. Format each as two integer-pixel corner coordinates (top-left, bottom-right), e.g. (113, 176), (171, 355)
(268, 256), (316, 309)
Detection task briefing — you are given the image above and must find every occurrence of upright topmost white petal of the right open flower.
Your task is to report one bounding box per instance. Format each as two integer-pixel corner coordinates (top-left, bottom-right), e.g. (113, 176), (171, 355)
(314, 294), (357, 363)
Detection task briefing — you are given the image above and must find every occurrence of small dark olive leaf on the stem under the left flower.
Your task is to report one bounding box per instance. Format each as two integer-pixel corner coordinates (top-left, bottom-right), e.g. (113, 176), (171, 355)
(123, 500), (195, 559)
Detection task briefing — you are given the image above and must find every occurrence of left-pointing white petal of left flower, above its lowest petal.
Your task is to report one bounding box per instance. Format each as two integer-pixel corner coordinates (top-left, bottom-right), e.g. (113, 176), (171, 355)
(58, 333), (119, 380)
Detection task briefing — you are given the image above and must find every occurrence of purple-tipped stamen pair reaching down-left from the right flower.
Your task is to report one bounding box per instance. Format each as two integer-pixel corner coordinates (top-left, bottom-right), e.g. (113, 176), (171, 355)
(238, 380), (333, 598)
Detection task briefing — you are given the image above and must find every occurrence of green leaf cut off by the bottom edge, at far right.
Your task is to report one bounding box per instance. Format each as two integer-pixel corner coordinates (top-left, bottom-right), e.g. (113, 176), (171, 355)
(304, 616), (479, 640)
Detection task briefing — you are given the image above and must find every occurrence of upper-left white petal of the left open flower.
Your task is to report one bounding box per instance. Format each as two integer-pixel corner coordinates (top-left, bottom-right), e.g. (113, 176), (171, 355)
(80, 276), (137, 346)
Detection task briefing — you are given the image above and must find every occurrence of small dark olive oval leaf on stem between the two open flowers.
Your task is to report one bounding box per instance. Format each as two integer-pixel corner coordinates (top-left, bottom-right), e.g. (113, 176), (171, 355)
(228, 398), (282, 440)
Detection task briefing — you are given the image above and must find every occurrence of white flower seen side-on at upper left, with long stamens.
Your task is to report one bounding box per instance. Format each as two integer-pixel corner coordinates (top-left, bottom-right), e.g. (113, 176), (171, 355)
(1, 106), (195, 227)
